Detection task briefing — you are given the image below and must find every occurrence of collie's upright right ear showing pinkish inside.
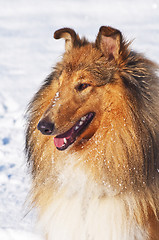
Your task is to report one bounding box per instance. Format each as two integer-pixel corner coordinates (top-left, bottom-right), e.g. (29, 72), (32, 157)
(96, 26), (122, 60)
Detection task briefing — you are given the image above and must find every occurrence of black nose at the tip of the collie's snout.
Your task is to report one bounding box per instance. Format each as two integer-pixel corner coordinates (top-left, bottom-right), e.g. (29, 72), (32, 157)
(37, 119), (54, 135)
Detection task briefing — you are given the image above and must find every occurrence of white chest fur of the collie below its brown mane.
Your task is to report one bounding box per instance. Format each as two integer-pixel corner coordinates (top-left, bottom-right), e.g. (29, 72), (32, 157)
(39, 159), (147, 240)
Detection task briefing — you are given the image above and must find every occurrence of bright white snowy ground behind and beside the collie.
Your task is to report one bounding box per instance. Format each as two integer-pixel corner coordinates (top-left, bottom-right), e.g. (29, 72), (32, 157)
(0, 0), (159, 240)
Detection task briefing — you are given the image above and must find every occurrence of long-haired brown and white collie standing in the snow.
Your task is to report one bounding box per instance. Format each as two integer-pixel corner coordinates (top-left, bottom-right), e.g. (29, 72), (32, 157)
(26, 26), (159, 240)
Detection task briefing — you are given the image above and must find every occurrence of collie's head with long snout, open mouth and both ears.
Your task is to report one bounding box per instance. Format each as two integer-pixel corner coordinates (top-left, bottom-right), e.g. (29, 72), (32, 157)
(38, 27), (128, 150)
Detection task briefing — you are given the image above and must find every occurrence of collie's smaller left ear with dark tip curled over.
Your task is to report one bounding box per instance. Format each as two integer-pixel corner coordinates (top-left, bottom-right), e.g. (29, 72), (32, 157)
(54, 28), (78, 52)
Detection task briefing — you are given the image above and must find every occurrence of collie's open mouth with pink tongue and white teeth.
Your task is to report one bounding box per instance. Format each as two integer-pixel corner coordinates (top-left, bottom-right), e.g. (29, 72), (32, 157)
(54, 112), (95, 151)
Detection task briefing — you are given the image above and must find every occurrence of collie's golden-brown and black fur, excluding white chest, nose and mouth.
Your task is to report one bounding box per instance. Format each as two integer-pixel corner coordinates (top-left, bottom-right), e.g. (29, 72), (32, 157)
(26, 27), (159, 240)
